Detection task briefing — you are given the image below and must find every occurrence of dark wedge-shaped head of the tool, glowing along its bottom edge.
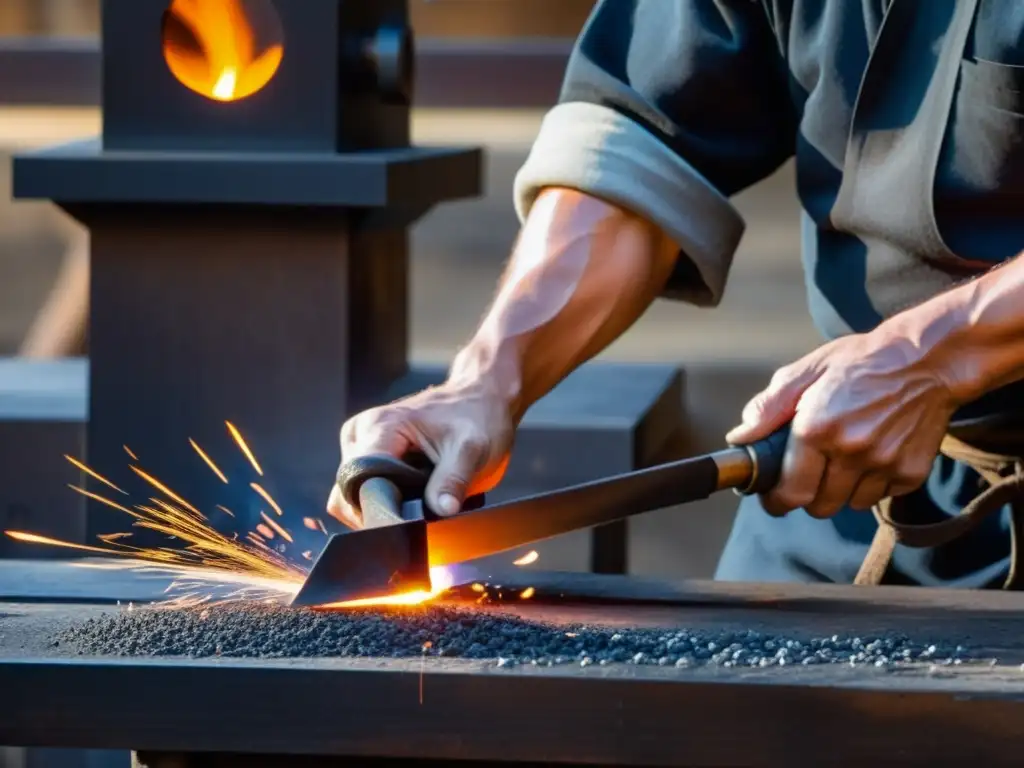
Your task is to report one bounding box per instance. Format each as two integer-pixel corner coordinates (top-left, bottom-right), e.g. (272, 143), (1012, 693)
(292, 520), (431, 606)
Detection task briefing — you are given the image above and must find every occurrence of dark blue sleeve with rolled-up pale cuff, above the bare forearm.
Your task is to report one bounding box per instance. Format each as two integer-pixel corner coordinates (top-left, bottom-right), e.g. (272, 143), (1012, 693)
(515, 0), (798, 306)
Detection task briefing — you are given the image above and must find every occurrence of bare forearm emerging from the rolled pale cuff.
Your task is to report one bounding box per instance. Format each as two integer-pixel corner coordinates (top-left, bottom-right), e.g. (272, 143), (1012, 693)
(450, 188), (678, 422)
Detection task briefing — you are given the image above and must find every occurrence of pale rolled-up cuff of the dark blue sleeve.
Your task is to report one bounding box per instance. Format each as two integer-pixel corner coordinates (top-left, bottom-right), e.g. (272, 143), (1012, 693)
(514, 101), (745, 306)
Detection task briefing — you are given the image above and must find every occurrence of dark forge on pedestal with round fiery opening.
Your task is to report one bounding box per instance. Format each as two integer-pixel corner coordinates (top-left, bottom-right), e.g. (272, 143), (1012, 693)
(13, 0), (481, 545)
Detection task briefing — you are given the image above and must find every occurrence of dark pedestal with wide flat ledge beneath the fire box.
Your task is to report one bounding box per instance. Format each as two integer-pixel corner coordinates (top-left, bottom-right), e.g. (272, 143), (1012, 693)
(14, 142), (480, 544)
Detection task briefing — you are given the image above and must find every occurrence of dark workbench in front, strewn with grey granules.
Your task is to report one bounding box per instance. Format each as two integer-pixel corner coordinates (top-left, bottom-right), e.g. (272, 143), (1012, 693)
(0, 565), (1024, 766)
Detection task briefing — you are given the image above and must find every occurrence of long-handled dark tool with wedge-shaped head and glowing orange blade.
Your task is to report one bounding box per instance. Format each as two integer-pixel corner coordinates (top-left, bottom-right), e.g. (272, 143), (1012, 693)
(292, 426), (790, 606)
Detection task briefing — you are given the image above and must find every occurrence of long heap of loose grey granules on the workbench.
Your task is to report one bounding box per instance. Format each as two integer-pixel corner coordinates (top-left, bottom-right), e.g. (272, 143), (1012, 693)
(52, 604), (970, 668)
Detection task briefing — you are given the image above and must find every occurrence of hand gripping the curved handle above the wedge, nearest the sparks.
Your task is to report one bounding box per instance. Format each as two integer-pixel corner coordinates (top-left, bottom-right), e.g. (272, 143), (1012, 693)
(327, 382), (514, 528)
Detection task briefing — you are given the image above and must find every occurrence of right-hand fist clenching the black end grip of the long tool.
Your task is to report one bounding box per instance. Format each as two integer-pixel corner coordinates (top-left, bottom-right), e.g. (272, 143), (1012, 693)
(726, 325), (961, 518)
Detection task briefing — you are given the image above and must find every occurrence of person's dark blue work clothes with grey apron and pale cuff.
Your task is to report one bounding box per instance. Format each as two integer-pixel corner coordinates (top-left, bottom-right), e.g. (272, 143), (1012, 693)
(515, 0), (1024, 586)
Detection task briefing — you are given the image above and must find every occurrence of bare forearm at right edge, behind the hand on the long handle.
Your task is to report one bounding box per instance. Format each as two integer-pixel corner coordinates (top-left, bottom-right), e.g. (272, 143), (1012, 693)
(880, 257), (1024, 403)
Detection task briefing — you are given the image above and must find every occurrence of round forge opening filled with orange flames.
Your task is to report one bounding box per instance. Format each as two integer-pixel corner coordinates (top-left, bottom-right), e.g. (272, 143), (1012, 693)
(161, 0), (285, 101)
